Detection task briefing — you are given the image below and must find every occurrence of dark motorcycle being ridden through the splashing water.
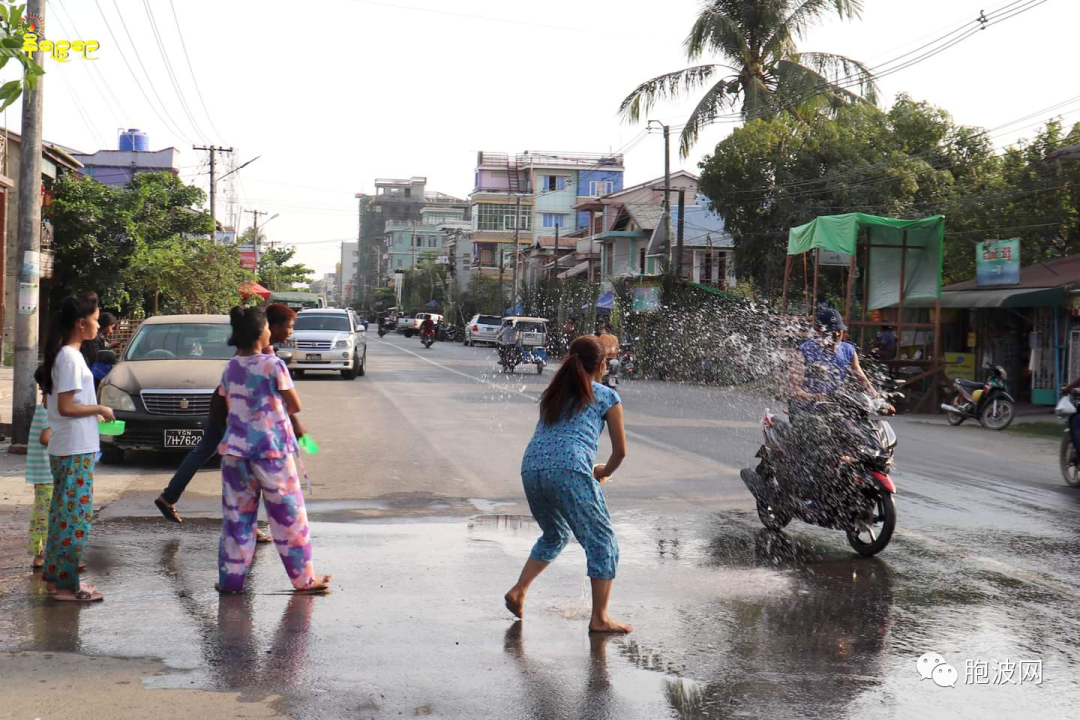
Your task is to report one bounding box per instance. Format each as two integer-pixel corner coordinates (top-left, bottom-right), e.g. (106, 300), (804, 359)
(740, 393), (896, 556)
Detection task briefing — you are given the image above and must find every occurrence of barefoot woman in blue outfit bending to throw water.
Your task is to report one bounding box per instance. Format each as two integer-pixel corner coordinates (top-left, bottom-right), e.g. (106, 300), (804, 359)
(505, 336), (633, 633)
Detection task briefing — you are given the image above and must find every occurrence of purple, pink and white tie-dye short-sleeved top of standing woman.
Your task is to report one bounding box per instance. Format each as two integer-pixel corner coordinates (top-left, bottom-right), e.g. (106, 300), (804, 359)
(217, 353), (297, 459)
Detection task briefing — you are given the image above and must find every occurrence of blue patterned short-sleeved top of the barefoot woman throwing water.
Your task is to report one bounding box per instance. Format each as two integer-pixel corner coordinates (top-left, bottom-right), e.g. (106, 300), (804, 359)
(522, 382), (622, 477)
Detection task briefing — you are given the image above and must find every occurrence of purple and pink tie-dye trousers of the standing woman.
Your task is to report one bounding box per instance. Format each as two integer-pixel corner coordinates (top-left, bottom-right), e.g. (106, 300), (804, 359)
(218, 456), (315, 592)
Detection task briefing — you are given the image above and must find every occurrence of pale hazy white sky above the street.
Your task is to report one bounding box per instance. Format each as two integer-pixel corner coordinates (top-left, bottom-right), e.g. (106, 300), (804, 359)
(5, 0), (1080, 272)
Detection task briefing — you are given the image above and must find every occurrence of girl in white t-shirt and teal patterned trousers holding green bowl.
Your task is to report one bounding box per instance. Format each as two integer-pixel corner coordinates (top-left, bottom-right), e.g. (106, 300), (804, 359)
(41, 293), (114, 602)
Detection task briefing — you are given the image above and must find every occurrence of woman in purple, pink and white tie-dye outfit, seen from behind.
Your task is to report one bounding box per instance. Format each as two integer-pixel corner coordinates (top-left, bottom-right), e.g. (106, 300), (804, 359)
(216, 308), (330, 593)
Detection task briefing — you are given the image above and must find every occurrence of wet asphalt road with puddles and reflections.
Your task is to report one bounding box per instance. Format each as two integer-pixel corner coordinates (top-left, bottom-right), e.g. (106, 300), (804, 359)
(0, 337), (1080, 718)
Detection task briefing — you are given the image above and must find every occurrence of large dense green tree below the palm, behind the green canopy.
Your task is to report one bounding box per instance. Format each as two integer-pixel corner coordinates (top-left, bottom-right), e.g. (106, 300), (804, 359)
(700, 95), (1007, 295)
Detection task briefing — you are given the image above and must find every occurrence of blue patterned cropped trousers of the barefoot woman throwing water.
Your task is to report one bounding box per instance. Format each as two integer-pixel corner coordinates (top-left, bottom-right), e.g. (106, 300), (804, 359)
(522, 470), (619, 580)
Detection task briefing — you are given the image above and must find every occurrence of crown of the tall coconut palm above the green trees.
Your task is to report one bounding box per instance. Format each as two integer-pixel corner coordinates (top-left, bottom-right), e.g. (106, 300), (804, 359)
(619, 0), (877, 158)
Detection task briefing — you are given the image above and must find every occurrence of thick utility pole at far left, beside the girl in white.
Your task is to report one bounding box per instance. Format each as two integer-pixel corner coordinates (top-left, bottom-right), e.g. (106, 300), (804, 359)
(9, 0), (45, 454)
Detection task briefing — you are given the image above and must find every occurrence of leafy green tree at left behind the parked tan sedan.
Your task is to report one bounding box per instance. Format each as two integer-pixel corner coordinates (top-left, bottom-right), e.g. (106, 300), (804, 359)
(46, 173), (216, 314)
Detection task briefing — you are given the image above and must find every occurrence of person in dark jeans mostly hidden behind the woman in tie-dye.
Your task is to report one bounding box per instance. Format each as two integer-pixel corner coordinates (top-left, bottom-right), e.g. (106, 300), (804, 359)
(153, 302), (303, 535)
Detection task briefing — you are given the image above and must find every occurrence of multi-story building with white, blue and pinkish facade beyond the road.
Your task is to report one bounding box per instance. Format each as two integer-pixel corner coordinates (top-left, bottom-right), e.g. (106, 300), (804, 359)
(469, 151), (623, 287)
